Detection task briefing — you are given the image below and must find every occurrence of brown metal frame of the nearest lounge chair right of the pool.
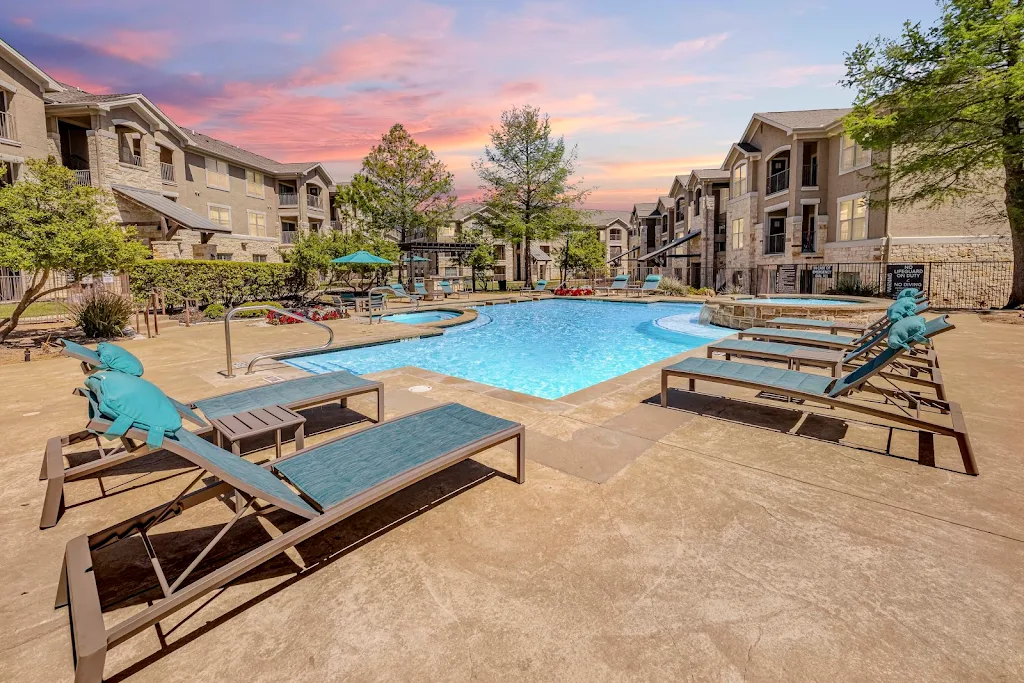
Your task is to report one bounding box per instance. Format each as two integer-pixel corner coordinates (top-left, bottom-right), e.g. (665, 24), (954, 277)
(662, 351), (978, 476)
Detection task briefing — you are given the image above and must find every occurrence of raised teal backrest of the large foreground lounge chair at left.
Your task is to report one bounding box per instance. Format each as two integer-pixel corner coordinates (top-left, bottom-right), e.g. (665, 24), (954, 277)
(164, 429), (318, 519)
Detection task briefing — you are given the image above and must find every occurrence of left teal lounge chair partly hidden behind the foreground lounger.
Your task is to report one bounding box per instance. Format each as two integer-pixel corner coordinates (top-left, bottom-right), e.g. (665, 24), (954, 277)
(39, 340), (384, 528)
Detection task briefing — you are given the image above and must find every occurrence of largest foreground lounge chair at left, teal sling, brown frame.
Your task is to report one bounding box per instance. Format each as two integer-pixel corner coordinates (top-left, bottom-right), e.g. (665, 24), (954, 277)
(55, 403), (525, 683)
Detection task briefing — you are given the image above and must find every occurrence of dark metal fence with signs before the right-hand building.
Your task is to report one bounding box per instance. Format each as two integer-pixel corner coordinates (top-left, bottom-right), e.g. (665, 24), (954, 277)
(634, 261), (1013, 309)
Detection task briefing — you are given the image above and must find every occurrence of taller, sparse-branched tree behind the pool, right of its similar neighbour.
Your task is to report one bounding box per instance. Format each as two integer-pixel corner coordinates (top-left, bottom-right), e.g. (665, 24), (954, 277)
(473, 105), (590, 285)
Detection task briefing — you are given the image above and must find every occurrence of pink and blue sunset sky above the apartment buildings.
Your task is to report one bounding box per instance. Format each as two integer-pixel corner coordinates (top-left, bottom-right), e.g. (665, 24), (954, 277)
(0, 0), (937, 209)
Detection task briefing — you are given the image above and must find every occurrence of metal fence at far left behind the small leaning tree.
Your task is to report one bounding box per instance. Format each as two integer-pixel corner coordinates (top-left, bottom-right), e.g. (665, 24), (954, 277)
(0, 271), (131, 323)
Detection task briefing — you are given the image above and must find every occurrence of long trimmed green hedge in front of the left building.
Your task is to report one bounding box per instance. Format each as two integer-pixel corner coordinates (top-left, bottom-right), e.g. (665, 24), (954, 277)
(129, 260), (292, 306)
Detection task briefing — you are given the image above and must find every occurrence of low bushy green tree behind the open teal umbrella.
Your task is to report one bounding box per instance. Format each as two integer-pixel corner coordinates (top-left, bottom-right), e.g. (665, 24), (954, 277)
(286, 230), (400, 299)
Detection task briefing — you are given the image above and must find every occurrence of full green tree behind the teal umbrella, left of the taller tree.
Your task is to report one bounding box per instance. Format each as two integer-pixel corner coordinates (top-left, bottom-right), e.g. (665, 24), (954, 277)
(352, 123), (456, 287)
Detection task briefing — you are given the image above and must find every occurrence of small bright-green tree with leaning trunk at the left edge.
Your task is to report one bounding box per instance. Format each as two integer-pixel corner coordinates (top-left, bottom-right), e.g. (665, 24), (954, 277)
(0, 159), (148, 341)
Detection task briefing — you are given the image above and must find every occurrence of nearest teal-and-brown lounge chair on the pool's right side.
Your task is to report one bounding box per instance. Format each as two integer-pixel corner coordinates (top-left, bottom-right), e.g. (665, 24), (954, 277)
(662, 315), (978, 475)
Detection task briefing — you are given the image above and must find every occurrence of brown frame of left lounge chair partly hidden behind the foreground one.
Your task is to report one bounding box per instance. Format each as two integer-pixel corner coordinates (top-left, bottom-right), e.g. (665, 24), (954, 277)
(39, 378), (384, 528)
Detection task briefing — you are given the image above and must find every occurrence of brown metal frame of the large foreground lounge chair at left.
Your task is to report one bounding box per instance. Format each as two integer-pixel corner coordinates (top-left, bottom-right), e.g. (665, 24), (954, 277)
(54, 403), (526, 683)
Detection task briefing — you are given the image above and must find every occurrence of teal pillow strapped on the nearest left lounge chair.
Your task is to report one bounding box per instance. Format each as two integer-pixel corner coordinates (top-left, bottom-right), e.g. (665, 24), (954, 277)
(85, 371), (181, 449)
